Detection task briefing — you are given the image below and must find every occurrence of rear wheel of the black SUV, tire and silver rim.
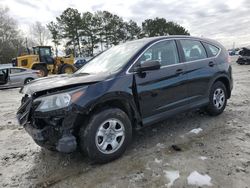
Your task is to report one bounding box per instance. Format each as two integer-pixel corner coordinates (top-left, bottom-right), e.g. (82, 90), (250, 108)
(206, 81), (227, 116)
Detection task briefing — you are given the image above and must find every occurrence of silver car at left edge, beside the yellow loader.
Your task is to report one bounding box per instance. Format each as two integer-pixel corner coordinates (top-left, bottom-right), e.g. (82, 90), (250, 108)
(0, 67), (39, 89)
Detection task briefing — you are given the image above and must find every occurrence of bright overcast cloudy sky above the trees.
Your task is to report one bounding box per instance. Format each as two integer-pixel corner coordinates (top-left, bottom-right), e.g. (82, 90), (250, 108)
(0, 0), (250, 48)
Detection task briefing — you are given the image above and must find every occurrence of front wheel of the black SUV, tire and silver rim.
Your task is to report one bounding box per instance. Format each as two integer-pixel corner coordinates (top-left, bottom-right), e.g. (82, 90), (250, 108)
(79, 108), (132, 163)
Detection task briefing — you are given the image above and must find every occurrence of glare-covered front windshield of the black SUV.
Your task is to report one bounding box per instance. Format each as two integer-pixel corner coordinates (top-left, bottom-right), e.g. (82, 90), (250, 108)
(76, 40), (146, 74)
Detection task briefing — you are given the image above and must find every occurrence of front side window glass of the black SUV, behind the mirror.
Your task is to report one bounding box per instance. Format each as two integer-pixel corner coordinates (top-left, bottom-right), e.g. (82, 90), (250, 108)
(138, 40), (179, 66)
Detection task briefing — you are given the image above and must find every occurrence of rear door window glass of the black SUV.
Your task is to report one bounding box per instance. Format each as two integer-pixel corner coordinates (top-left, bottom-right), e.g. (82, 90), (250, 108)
(180, 39), (207, 61)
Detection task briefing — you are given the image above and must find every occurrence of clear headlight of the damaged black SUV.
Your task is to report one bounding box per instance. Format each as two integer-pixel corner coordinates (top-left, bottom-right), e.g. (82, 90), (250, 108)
(34, 90), (84, 112)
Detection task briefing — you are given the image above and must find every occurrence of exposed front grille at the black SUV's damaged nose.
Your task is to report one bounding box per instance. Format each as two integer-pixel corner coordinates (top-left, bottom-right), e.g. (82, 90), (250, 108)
(17, 96), (32, 126)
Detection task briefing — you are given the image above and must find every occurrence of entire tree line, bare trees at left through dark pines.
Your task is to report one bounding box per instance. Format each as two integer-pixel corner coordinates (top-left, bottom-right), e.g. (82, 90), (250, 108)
(0, 7), (189, 64)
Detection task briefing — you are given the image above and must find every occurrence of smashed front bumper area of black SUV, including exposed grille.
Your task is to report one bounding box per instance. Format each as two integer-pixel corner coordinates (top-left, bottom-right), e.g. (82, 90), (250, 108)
(17, 97), (80, 153)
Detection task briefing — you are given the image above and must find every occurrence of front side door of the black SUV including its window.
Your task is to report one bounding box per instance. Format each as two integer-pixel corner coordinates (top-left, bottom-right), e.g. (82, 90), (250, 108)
(134, 40), (188, 124)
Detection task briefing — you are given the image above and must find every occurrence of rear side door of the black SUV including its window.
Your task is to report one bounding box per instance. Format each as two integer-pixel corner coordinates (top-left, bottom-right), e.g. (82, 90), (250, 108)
(179, 39), (219, 105)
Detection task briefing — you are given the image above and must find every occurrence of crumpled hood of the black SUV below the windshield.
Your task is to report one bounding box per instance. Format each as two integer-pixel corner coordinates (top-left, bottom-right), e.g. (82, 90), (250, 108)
(20, 73), (109, 94)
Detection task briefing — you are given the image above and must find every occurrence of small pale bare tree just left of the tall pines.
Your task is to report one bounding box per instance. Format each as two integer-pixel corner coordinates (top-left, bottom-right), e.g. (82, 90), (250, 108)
(30, 22), (50, 46)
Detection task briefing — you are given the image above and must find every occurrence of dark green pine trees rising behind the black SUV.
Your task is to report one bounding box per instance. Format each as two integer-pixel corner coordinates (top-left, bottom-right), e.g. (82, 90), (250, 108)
(47, 8), (189, 56)
